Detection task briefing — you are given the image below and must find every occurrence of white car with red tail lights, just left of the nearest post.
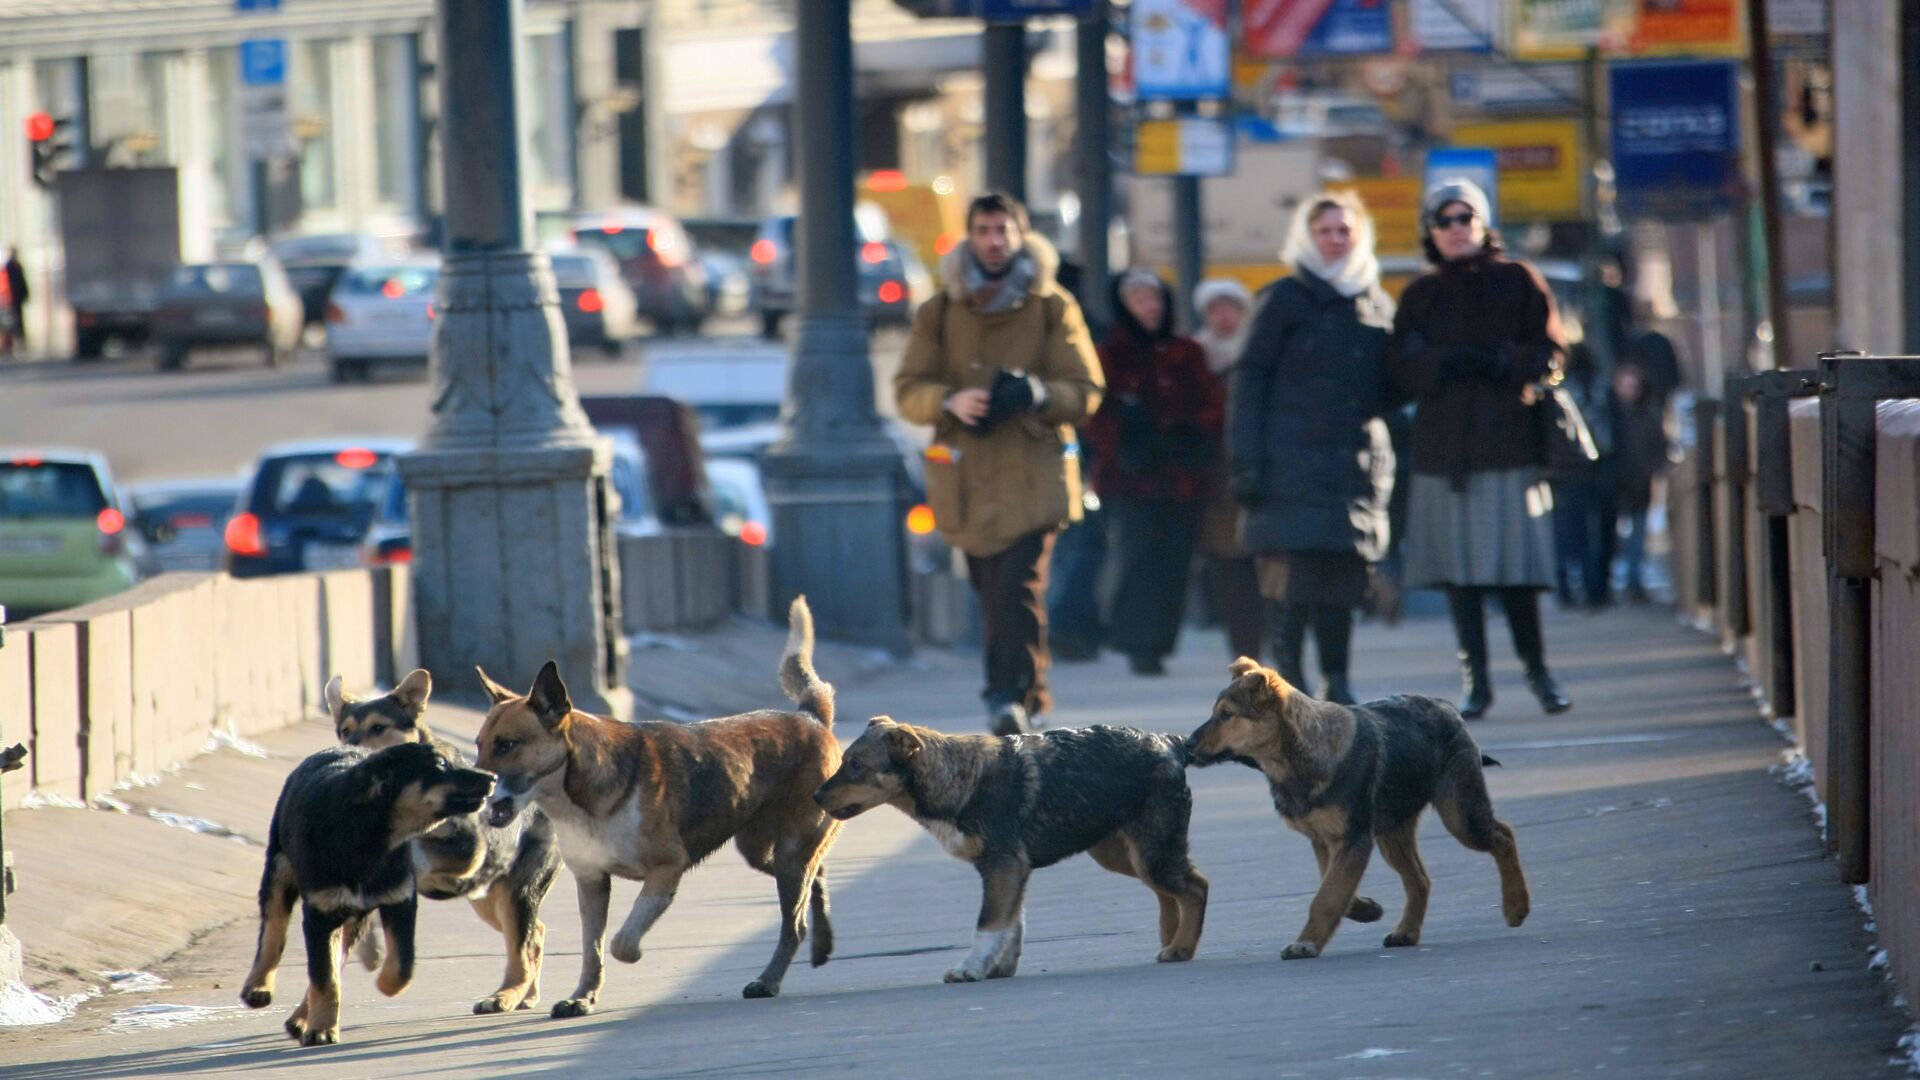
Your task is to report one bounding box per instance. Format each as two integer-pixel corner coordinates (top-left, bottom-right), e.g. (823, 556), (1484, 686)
(326, 256), (440, 382)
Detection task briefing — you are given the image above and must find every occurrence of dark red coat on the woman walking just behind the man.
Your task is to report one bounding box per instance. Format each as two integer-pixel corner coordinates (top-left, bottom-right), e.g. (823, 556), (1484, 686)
(1087, 272), (1227, 502)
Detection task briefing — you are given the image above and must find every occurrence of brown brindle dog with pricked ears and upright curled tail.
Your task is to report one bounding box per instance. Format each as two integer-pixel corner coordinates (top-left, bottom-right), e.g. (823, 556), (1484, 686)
(480, 600), (839, 1017)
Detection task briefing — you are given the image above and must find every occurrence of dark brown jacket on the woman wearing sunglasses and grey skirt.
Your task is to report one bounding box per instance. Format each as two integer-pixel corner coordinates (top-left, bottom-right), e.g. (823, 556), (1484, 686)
(1392, 254), (1567, 480)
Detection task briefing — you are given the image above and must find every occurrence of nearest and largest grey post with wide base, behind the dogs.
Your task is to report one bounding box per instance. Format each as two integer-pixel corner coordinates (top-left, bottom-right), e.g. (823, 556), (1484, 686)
(399, 0), (632, 717)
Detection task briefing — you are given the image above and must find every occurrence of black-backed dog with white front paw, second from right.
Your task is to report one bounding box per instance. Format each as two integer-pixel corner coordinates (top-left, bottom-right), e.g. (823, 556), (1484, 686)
(814, 717), (1208, 982)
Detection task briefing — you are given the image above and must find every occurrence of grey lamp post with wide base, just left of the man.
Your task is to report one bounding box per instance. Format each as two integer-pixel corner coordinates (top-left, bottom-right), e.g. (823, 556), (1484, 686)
(764, 0), (908, 653)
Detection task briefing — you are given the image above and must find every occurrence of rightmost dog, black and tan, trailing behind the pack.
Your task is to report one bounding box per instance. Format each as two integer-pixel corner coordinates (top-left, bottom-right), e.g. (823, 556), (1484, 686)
(1188, 657), (1530, 961)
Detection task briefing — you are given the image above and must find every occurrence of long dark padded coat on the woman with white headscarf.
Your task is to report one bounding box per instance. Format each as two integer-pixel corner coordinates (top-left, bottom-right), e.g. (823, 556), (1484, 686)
(1227, 271), (1394, 561)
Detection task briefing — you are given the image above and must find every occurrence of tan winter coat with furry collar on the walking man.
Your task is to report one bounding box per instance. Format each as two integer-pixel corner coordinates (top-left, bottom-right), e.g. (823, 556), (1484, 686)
(893, 234), (1100, 557)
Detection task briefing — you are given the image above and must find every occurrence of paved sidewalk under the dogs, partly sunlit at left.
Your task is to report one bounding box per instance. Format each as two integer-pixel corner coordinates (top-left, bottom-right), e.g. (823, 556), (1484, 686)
(0, 609), (1910, 1078)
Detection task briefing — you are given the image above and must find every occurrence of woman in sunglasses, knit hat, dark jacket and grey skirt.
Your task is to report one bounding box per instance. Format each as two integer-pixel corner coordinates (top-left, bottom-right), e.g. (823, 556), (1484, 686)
(1394, 181), (1572, 719)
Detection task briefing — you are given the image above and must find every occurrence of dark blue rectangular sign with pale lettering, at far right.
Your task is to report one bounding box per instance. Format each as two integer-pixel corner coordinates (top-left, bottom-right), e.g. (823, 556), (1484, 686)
(1611, 60), (1741, 211)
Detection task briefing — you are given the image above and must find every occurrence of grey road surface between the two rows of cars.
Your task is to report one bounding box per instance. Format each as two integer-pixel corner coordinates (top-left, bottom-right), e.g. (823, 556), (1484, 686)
(0, 321), (902, 484)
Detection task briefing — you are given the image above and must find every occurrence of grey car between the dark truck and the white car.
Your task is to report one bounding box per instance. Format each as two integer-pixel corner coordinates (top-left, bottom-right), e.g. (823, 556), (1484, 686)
(152, 256), (301, 371)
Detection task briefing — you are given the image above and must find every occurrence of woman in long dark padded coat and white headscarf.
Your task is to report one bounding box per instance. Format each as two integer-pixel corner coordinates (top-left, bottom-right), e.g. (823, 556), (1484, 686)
(1227, 194), (1394, 705)
